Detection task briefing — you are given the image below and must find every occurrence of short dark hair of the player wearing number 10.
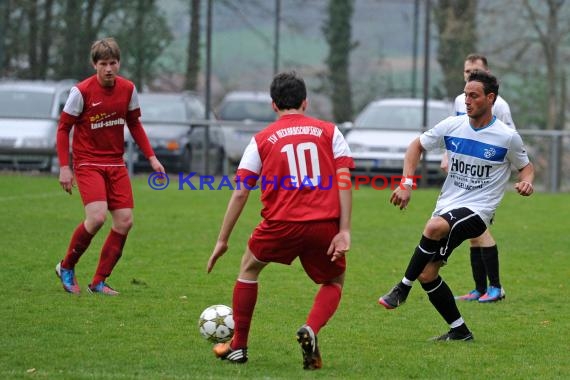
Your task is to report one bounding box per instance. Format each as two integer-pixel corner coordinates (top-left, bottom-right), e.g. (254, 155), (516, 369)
(269, 71), (307, 110)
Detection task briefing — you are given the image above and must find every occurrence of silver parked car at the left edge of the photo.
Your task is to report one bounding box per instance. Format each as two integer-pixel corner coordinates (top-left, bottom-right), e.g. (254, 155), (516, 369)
(0, 80), (76, 171)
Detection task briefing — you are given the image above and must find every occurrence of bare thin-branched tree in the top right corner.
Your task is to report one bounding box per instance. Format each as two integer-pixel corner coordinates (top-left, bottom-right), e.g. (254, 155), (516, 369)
(479, 0), (570, 129)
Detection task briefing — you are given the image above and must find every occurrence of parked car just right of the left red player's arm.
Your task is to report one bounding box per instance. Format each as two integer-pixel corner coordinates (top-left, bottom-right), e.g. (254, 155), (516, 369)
(125, 92), (224, 174)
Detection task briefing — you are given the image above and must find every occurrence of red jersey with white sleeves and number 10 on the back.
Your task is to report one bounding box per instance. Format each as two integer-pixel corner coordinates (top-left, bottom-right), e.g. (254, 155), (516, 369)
(236, 114), (354, 222)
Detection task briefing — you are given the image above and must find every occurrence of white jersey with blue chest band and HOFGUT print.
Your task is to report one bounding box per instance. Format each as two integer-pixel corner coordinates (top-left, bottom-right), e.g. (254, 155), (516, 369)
(420, 115), (530, 225)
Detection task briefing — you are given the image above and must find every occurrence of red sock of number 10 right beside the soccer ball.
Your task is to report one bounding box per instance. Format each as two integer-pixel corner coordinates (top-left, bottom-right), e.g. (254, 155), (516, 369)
(231, 280), (257, 350)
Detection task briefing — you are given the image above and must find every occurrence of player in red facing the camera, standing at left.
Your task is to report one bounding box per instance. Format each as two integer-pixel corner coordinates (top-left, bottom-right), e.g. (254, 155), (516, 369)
(55, 38), (164, 295)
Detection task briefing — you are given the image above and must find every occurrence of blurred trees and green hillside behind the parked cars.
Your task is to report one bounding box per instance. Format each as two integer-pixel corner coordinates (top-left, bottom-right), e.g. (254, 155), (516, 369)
(0, 0), (570, 129)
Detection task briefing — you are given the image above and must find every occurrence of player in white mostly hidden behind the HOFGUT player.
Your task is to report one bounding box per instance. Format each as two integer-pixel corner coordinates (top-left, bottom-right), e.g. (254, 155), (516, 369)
(448, 54), (516, 303)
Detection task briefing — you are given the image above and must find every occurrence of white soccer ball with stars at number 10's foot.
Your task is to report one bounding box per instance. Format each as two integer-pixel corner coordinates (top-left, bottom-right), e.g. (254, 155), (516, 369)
(198, 305), (234, 343)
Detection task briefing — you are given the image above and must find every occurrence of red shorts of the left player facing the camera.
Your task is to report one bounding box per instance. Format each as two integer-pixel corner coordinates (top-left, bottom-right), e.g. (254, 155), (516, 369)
(75, 165), (134, 210)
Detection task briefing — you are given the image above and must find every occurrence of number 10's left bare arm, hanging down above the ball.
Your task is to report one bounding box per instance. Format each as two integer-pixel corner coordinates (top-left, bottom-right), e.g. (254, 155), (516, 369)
(206, 186), (249, 273)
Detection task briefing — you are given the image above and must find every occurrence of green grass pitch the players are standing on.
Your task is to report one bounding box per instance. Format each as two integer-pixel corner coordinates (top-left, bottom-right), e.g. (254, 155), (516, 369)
(0, 175), (570, 379)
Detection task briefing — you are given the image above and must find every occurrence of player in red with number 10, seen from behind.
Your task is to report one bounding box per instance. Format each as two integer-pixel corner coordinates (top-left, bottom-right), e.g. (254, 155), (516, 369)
(207, 72), (354, 369)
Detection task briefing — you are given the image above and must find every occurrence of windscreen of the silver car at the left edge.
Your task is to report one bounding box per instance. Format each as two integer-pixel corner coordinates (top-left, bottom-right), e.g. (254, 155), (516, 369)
(0, 90), (53, 118)
